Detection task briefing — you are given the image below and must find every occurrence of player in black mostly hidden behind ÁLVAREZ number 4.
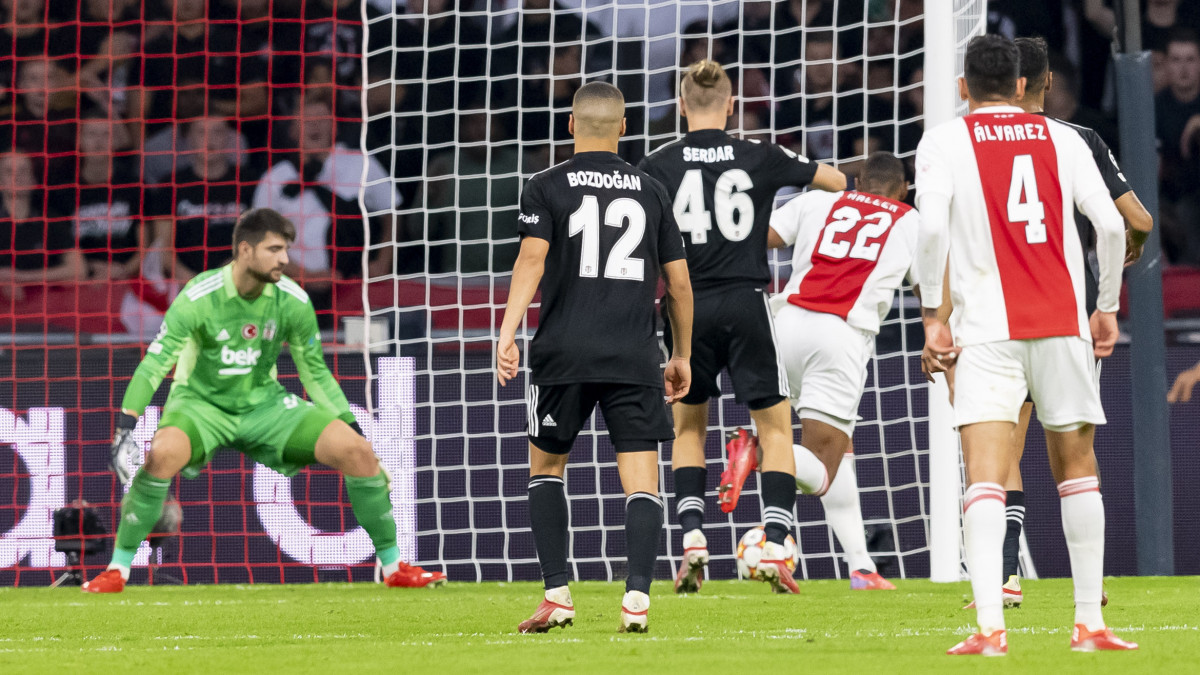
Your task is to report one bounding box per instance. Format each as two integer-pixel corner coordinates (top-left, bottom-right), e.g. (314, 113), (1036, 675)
(938, 37), (1154, 608)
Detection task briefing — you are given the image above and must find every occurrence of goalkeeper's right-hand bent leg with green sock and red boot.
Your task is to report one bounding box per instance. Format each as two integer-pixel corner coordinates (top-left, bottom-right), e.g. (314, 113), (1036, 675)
(319, 419), (446, 589)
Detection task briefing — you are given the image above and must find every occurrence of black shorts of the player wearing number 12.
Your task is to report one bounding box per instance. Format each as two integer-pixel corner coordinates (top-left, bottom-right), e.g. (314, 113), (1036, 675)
(526, 382), (674, 454)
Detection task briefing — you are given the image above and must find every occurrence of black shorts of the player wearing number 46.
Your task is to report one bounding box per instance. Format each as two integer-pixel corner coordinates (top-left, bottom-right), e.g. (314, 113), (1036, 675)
(662, 286), (788, 410)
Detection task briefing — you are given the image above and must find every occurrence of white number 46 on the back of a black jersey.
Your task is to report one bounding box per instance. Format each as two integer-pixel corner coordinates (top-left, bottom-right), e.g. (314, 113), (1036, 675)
(673, 169), (754, 244)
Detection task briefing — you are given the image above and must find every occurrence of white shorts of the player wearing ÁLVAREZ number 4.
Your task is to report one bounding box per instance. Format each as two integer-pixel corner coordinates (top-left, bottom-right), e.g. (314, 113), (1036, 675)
(954, 338), (1108, 431)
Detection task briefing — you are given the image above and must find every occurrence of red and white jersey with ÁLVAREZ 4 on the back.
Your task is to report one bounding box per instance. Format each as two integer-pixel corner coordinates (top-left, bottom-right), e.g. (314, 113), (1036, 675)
(917, 106), (1120, 346)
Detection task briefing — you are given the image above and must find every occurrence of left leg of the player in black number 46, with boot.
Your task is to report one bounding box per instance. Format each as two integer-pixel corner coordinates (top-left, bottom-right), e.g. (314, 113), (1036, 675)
(671, 402), (708, 593)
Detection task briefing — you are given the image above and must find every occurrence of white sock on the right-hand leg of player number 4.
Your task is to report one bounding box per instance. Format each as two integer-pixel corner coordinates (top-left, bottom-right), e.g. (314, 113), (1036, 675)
(1058, 476), (1104, 631)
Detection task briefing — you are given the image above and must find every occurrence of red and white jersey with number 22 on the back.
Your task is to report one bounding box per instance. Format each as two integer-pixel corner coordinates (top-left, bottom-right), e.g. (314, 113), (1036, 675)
(770, 191), (920, 334)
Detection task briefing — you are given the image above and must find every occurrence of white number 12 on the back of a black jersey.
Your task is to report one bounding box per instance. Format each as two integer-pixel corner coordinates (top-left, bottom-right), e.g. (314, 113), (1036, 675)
(569, 195), (646, 281)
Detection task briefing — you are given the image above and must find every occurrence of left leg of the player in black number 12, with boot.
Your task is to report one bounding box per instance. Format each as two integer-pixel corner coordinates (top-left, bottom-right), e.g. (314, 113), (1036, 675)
(517, 443), (575, 633)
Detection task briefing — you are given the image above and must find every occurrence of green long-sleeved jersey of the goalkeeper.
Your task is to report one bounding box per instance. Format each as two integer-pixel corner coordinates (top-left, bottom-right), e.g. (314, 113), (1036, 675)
(121, 263), (354, 422)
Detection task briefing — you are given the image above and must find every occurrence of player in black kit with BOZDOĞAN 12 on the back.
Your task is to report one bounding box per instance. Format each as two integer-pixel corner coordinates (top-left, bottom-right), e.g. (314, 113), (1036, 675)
(496, 82), (691, 633)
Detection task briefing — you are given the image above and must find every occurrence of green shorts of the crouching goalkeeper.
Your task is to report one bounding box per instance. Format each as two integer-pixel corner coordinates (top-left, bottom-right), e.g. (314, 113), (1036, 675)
(158, 389), (337, 478)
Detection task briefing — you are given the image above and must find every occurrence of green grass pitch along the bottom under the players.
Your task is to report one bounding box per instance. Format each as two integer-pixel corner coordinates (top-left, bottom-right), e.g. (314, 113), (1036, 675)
(0, 577), (1200, 675)
